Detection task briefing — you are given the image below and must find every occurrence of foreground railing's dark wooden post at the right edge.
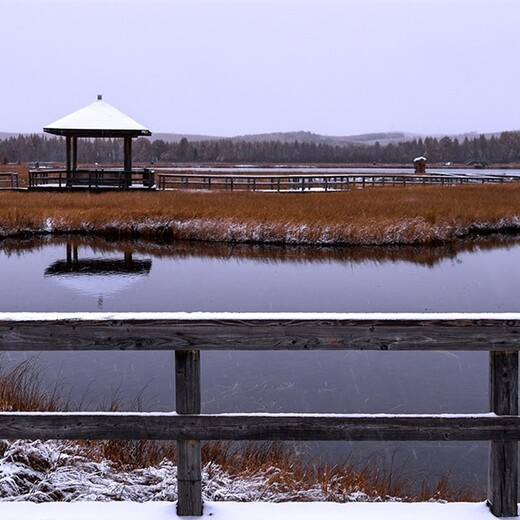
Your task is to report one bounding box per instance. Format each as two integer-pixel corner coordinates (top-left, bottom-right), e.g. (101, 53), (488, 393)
(488, 351), (518, 516)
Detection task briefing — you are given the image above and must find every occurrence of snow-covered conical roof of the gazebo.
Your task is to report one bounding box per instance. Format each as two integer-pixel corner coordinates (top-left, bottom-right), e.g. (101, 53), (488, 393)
(43, 95), (152, 137)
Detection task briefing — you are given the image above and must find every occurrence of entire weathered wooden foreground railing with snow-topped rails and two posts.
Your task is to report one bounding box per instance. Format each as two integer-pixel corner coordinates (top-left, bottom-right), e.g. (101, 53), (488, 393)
(0, 313), (520, 516)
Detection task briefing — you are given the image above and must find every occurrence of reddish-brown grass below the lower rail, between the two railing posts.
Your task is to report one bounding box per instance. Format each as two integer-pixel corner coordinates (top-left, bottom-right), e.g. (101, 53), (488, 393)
(203, 442), (482, 502)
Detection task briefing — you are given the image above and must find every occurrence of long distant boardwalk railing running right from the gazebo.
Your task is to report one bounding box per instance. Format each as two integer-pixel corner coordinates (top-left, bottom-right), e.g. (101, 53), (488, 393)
(158, 171), (520, 192)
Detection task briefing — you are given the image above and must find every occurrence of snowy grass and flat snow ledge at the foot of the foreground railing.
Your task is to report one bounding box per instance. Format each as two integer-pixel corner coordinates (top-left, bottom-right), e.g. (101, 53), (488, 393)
(0, 441), (500, 520)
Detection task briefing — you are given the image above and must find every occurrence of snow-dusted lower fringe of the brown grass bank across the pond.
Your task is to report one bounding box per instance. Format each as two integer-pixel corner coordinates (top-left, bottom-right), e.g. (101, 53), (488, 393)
(14, 217), (520, 246)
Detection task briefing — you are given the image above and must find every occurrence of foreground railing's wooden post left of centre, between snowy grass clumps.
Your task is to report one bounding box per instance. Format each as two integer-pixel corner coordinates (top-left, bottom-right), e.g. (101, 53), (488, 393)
(175, 350), (202, 516)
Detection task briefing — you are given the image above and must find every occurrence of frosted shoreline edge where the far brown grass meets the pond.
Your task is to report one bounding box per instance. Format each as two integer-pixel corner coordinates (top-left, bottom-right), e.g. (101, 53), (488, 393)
(0, 218), (520, 247)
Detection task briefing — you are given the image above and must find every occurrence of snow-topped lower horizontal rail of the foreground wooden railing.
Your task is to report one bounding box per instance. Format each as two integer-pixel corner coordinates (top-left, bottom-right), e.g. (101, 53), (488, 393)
(0, 412), (520, 441)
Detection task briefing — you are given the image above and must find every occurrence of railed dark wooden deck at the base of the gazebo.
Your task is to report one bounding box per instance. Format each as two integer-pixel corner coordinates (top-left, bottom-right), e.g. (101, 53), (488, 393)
(28, 168), (156, 190)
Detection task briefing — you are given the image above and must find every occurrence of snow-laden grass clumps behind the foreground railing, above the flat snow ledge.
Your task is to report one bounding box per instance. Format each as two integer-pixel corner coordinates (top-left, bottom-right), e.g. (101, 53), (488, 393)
(0, 440), (392, 503)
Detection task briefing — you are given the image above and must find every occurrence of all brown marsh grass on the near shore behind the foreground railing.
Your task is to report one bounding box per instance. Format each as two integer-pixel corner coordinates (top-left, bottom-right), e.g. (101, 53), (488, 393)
(0, 361), (481, 502)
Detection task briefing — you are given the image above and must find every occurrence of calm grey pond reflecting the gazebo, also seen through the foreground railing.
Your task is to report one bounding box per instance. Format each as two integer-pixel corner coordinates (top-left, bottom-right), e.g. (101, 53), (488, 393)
(0, 237), (520, 491)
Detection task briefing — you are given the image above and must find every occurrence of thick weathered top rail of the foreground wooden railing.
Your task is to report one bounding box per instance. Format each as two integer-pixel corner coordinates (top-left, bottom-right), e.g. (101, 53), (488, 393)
(0, 313), (520, 351)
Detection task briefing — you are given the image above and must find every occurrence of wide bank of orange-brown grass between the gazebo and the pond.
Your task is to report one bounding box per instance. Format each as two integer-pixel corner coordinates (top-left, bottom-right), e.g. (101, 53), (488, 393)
(0, 183), (520, 245)
